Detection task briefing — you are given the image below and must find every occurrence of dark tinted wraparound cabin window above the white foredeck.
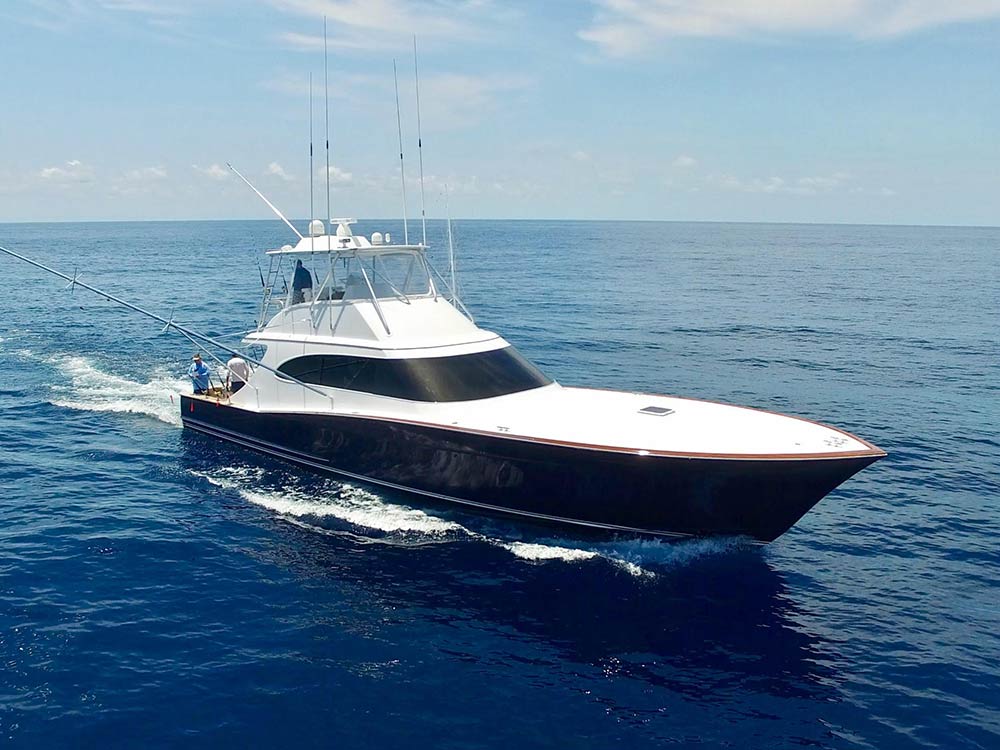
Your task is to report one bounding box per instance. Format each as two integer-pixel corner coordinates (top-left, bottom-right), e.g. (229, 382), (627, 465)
(278, 347), (552, 401)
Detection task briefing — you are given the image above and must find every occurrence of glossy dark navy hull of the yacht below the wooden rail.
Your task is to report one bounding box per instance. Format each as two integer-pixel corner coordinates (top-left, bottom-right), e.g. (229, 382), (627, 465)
(181, 396), (880, 542)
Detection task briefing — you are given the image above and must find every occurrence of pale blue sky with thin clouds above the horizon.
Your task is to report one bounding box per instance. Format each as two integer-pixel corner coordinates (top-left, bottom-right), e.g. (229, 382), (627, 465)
(0, 0), (1000, 225)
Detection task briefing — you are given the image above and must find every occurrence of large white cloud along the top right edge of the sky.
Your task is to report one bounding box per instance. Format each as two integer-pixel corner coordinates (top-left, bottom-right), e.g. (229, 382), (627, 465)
(578, 0), (1000, 57)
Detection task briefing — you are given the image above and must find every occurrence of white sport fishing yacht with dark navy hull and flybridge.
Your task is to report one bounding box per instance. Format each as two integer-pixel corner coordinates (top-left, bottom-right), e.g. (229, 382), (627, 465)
(175, 219), (885, 543)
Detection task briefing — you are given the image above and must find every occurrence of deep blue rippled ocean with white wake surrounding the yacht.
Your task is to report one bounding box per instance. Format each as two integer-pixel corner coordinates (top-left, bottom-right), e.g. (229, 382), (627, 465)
(0, 221), (1000, 750)
